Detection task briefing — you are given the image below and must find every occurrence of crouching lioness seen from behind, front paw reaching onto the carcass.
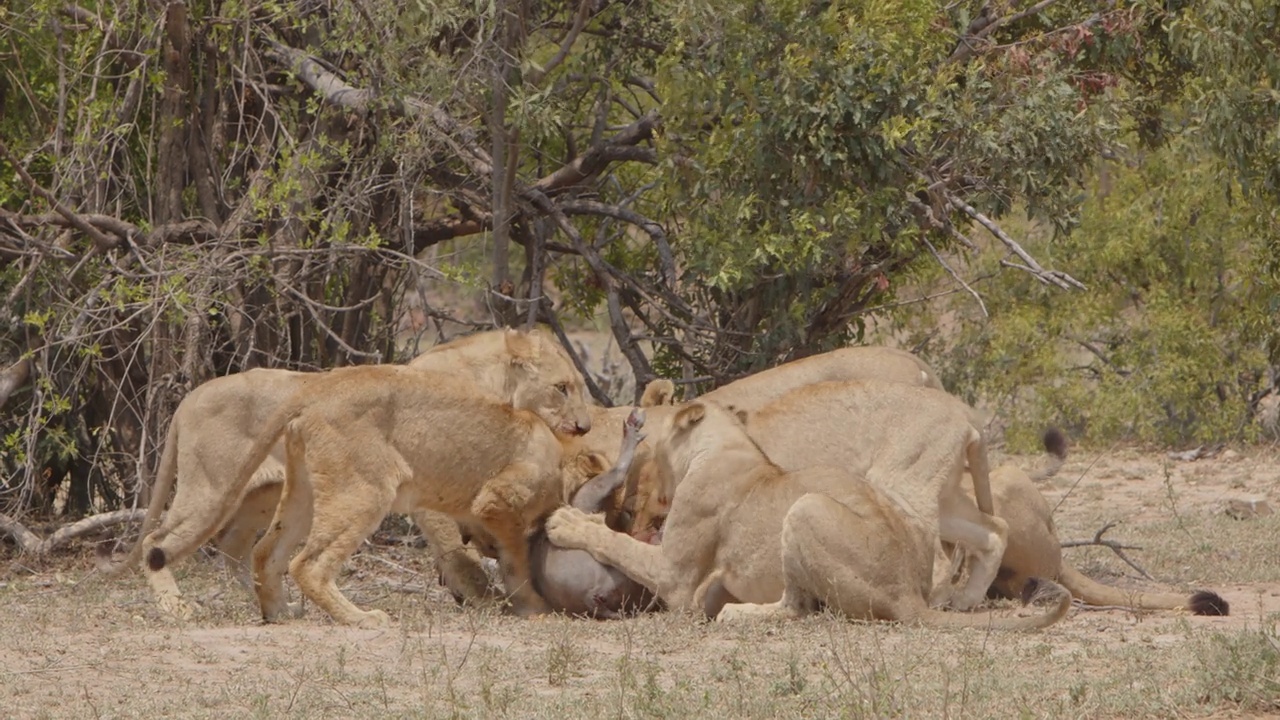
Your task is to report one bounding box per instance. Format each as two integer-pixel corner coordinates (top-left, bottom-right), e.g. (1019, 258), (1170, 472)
(547, 401), (1071, 630)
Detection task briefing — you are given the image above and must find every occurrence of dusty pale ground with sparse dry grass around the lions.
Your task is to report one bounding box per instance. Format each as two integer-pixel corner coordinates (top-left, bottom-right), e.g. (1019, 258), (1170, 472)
(0, 448), (1280, 719)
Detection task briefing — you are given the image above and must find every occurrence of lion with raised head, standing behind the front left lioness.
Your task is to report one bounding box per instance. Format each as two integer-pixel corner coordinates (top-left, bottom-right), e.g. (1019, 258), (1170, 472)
(111, 325), (590, 615)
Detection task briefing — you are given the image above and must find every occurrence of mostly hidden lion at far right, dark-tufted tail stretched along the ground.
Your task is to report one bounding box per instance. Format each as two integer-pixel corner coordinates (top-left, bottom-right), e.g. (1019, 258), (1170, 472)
(988, 428), (1230, 615)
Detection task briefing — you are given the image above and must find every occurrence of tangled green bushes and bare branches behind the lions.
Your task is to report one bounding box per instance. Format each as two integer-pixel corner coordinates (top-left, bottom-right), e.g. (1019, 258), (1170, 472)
(0, 0), (1280, 514)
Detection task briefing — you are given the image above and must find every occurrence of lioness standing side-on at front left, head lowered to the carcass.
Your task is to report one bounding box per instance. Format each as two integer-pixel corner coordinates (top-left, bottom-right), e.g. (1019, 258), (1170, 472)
(247, 365), (563, 626)
